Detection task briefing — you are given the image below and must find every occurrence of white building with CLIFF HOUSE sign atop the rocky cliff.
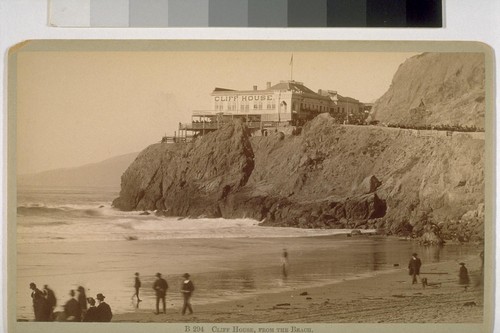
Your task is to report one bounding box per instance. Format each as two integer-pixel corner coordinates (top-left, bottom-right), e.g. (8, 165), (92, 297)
(179, 80), (364, 136)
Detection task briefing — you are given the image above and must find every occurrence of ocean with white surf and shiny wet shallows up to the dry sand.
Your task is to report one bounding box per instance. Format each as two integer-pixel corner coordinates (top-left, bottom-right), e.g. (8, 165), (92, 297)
(16, 187), (481, 320)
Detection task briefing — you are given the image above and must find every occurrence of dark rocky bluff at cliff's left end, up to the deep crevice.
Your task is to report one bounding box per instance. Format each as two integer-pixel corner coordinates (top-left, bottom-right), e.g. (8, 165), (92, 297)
(113, 123), (254, 217)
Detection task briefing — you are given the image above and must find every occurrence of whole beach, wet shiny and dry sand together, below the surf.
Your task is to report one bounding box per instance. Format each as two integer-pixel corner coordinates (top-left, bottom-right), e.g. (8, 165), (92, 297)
(17, 235), (483, 323)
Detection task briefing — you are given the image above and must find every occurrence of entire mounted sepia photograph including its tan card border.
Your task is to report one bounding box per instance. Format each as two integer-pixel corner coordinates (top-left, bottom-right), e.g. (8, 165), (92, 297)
(8, 40), (494, 333)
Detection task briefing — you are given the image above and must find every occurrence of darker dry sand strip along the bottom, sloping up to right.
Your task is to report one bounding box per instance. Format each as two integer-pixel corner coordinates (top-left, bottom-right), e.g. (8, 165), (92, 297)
(113, 254), (483, 323)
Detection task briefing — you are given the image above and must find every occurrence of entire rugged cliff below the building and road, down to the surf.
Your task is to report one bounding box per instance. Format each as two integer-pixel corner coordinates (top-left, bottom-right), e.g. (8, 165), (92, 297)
(113, 114), (484, 239)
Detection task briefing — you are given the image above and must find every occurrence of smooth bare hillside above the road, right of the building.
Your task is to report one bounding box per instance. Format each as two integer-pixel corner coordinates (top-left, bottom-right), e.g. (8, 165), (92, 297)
(372, 53), (485, 128)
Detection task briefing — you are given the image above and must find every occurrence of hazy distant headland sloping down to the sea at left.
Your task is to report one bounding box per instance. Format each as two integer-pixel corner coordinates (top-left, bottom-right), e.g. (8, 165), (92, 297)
(17, 153), (139, 187)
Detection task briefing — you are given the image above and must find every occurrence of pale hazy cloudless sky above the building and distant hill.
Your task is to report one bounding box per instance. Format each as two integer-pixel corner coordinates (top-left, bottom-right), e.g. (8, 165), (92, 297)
(16, 51), (415, 174)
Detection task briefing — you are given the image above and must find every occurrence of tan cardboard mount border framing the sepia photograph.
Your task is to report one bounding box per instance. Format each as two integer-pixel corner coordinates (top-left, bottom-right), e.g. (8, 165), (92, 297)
(6, 40), (496, 333)
